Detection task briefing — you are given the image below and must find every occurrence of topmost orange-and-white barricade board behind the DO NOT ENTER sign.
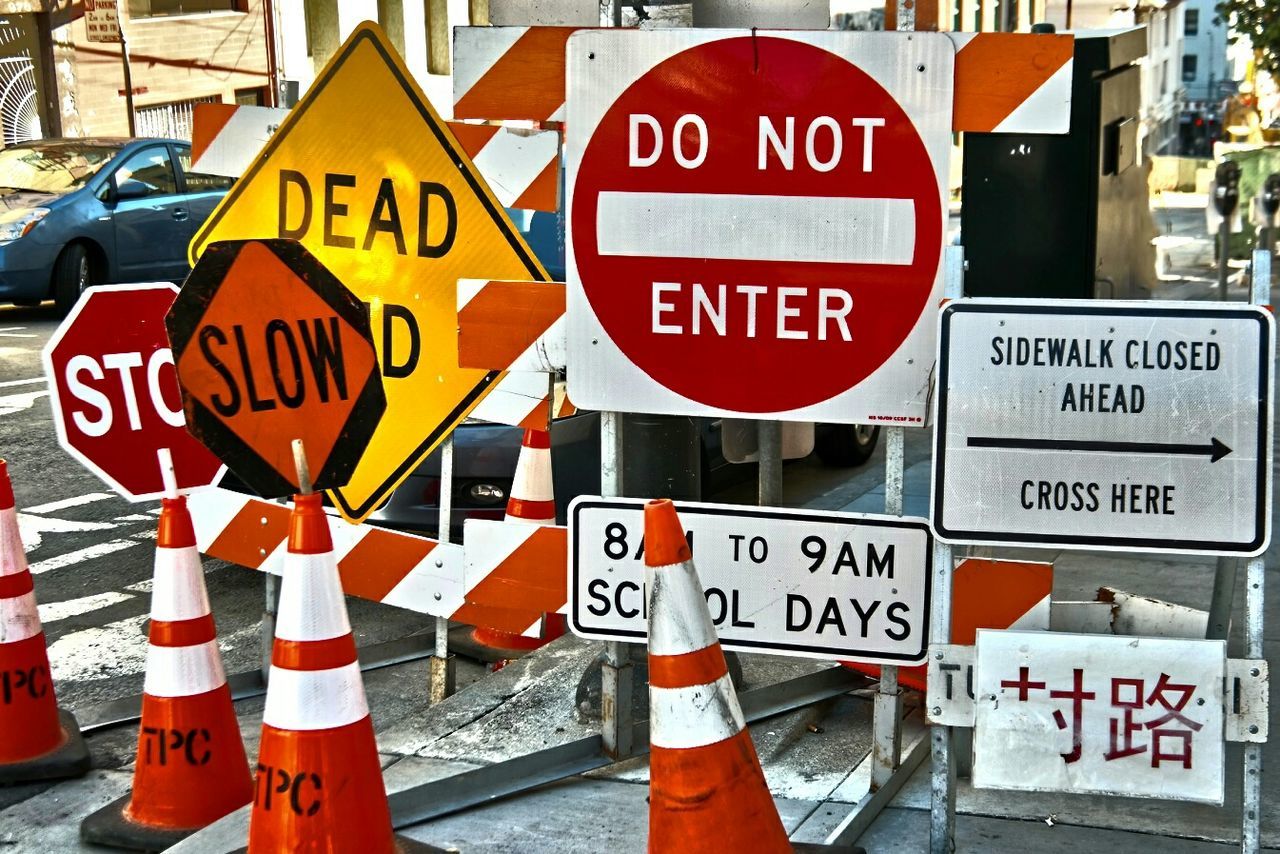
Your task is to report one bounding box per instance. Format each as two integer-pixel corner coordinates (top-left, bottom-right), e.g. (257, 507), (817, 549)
(453, 27), (1074, 133)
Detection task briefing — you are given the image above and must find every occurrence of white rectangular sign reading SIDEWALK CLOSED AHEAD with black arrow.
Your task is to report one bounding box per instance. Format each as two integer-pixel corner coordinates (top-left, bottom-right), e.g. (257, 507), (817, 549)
(933, 300), (1275, 554)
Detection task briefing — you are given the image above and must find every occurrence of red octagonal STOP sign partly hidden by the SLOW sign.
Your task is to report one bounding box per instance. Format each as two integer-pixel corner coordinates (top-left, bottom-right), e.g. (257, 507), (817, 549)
(44, 283), (223, 501)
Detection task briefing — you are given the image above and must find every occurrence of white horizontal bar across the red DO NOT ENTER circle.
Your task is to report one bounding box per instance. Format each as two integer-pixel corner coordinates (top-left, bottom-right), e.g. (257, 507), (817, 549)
(595, 192), (915, 265)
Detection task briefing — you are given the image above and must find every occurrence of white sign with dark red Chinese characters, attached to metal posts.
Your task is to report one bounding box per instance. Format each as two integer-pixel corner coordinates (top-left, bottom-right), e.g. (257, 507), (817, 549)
(973, 631), (1226, 804)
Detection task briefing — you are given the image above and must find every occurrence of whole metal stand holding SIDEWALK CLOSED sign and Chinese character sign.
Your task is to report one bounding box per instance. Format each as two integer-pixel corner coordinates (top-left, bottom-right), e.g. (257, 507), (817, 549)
(927, 252), (1274, 854)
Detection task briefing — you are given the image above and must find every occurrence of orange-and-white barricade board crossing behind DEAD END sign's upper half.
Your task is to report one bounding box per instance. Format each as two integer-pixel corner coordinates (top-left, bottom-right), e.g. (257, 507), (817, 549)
(191, 104), (561, 213)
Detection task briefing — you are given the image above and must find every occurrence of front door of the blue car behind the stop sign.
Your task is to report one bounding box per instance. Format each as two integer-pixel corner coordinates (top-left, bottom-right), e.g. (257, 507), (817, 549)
(110, 142), (191, 282)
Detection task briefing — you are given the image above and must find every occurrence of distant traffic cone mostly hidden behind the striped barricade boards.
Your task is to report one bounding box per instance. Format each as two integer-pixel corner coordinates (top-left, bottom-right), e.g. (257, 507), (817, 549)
(471, 430), (566, 655)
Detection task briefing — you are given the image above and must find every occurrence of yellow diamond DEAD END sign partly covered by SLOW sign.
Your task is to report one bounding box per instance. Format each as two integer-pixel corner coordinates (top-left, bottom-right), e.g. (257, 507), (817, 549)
(191, 23), (549, 521)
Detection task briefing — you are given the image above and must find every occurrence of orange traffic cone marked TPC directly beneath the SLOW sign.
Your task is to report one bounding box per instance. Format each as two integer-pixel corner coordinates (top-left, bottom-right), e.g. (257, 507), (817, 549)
(248, 494), (439, 854)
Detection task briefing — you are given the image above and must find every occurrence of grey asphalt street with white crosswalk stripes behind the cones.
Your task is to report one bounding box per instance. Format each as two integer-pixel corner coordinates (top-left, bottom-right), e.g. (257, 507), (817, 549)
(0, 295), (890, 737)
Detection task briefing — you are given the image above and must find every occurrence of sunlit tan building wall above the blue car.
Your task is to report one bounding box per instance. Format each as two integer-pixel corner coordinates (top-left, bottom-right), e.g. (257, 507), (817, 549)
(55, 0), (269, 136)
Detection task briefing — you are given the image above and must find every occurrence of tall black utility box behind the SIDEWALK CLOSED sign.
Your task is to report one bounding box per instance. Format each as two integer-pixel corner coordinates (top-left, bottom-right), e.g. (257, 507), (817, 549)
(960, 27), (1155, 300)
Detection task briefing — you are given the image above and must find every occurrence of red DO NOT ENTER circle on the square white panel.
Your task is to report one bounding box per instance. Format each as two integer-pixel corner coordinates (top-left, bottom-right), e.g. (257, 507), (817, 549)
(570, 36), (942, 412)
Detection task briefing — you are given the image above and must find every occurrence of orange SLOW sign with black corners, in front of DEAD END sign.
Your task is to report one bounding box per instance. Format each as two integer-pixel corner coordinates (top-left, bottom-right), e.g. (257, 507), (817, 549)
(165, 239), (387, 497)
